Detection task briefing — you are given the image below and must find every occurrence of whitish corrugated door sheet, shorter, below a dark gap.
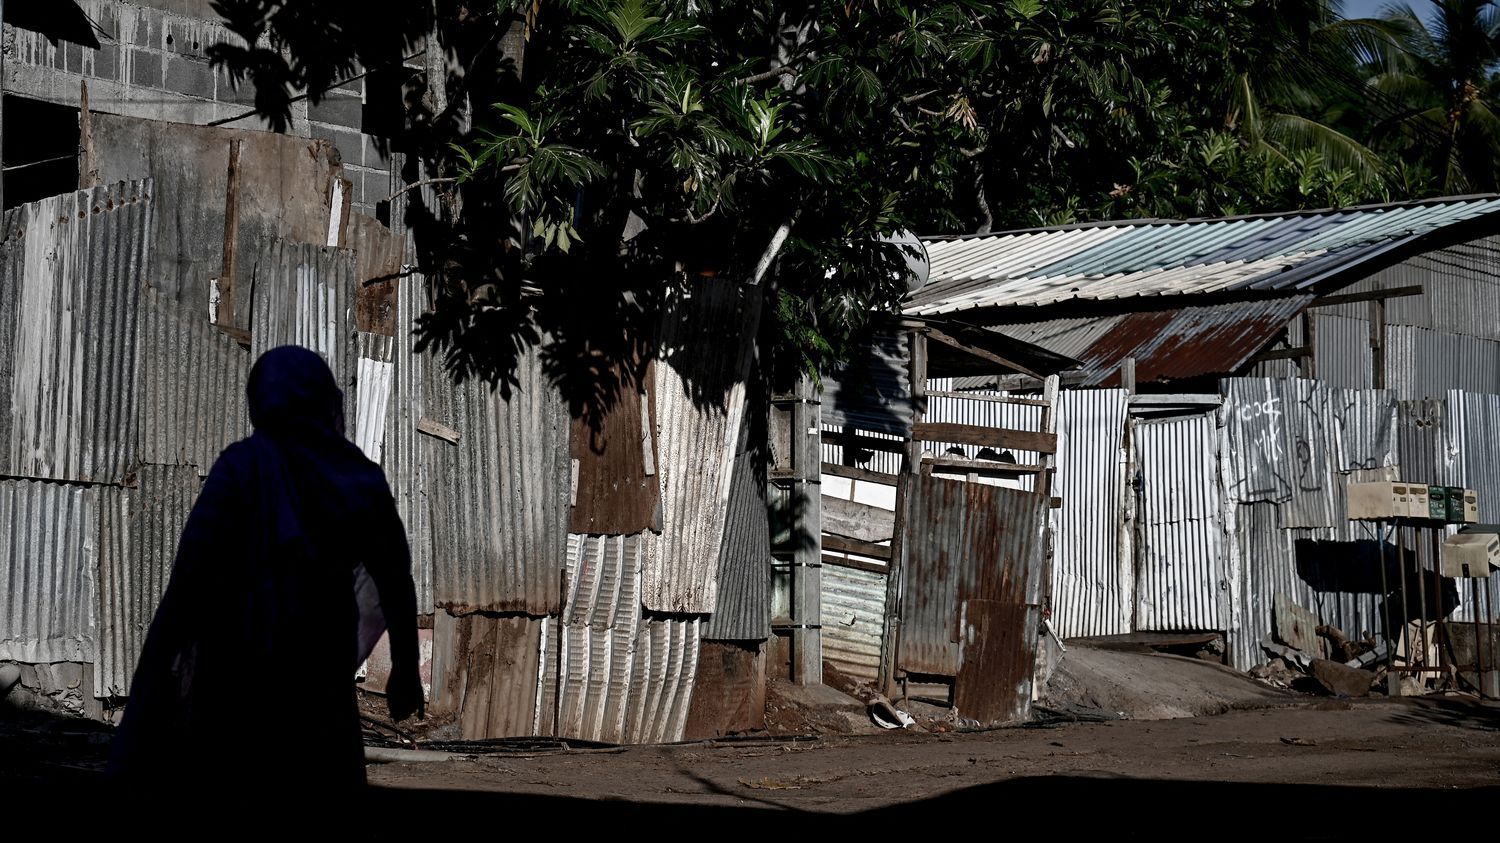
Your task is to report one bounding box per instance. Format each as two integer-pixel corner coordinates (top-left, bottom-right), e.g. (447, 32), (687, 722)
(1136, 414), (1230, 630)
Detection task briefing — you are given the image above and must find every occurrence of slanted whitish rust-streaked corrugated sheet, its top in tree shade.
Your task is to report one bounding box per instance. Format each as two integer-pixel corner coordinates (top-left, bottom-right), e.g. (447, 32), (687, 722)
(642, 278), (762, 609)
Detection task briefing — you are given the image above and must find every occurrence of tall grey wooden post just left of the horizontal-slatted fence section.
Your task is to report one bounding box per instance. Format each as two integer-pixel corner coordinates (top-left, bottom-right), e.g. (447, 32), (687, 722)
(792, 374), (824, 686)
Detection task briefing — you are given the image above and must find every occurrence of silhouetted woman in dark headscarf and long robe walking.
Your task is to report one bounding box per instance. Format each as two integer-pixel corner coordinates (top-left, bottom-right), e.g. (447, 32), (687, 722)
(110, 347), (422, 795)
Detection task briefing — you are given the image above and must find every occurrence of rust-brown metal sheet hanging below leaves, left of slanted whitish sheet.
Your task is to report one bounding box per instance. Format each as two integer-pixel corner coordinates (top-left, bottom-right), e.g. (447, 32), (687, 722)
(569, 355), (662, 536)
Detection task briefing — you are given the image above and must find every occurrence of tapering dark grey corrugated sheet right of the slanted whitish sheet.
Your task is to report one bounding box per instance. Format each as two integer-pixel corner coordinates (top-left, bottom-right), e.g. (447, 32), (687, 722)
(704, 450), (771, 641)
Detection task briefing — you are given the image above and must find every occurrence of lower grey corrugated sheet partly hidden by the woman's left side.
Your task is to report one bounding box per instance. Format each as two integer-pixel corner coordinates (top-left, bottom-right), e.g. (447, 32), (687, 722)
(95, 465), (201, 698)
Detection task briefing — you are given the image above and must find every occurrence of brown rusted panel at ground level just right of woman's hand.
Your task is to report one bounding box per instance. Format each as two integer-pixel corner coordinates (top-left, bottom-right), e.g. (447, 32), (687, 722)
(431, 603), (545, 740)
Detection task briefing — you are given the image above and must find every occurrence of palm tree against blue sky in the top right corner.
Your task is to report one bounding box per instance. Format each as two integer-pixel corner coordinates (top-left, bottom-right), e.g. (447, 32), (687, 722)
(1373, 0), (1500, 194)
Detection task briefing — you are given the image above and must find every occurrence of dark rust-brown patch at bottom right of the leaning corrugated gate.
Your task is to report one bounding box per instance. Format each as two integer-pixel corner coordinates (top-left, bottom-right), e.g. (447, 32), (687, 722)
(954, 600), (1037, 726)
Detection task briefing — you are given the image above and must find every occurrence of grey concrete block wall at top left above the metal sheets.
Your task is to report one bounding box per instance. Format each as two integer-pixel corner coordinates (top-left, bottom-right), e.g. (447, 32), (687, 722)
(3, 0), (399, 215)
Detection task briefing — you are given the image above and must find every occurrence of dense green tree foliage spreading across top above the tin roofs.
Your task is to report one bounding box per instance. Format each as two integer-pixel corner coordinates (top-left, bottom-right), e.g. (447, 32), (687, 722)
(213, 0), (1500, 383)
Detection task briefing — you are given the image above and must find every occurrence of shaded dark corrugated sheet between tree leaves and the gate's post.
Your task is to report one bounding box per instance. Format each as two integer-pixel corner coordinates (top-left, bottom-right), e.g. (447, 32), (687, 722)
(821, 332), (914, 437)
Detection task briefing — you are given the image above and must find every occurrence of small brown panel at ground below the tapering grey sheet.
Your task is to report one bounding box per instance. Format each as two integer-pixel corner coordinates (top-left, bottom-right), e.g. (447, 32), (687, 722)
(686, 641), (765, 741)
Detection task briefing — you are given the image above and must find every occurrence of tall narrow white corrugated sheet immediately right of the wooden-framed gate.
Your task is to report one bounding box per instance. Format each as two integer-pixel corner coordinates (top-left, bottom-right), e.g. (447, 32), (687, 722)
(1052, 390), (1136, 638)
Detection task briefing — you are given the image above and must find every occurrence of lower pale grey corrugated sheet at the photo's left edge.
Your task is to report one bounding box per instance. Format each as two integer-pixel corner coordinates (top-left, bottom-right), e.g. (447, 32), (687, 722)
(0, 480), (98, 663)
